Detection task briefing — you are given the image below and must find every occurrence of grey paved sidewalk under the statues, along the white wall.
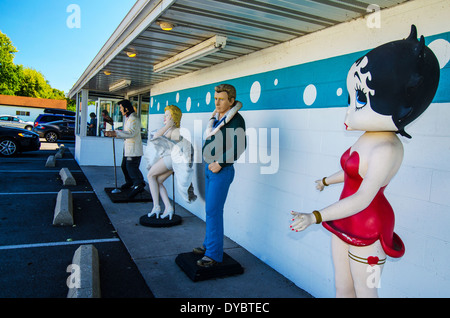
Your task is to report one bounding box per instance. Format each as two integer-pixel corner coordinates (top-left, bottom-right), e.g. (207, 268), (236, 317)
(81, 166), (311, 298)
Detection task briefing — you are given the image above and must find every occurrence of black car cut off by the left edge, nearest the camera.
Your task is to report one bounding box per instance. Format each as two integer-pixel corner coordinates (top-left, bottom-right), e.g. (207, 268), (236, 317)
(0, 125), (41, 157)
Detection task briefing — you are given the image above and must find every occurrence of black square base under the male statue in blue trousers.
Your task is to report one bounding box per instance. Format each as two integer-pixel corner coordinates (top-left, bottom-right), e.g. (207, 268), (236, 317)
(175, 252), (244, 282)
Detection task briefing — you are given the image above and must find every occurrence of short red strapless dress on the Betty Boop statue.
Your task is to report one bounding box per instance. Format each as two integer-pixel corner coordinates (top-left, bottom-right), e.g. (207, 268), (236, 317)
(322, 149), (405, 257)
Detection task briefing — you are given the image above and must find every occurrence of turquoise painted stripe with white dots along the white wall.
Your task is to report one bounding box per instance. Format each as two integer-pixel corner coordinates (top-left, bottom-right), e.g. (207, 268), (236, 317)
(150, 32), (450, 114)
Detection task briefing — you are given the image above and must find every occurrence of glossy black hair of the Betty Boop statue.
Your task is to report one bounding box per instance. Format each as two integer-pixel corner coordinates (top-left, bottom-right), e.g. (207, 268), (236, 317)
(357, 25), (440, 138)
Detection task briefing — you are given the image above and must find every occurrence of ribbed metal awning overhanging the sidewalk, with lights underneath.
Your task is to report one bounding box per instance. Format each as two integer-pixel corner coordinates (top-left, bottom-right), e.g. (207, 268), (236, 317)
(69, 0), (408, 97)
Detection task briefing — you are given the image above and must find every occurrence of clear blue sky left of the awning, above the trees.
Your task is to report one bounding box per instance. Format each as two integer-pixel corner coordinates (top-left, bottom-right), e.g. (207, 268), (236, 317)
(0, 0), (136, 94)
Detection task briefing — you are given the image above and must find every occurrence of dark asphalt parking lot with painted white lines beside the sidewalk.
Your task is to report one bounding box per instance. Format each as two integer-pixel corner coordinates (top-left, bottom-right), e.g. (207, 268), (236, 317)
(0, 142), (154, 298)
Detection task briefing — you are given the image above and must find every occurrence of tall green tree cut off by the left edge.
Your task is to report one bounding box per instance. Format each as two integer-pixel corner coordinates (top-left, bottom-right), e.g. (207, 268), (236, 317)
(0, 31), (23, 95)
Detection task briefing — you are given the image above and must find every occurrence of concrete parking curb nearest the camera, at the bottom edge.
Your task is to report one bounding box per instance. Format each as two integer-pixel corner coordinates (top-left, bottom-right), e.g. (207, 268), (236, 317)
(67, 244), (101, 298)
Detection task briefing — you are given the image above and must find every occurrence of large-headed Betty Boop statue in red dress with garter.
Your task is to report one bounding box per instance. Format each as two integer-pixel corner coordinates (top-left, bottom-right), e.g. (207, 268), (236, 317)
(291, 25), (439, 297)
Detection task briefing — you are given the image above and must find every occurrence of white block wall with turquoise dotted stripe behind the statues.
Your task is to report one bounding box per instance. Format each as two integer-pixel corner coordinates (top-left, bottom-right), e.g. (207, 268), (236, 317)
(149, 0), (450, 297)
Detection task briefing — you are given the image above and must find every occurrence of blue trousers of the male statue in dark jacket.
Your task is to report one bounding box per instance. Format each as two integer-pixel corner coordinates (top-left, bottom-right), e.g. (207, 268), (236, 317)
(203, 165), (234, 262)
